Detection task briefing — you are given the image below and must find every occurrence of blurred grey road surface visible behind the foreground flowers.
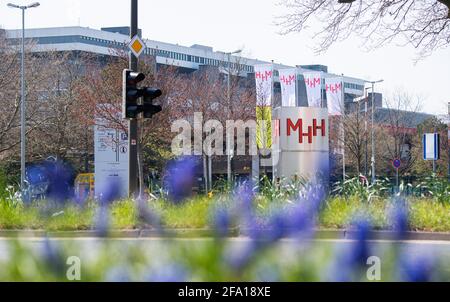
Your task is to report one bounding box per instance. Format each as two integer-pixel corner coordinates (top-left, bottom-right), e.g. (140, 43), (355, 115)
(0, 237), (450, 282)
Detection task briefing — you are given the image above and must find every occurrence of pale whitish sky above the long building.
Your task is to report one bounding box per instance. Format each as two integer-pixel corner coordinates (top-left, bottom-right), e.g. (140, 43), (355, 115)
(0, 0), (450, 114)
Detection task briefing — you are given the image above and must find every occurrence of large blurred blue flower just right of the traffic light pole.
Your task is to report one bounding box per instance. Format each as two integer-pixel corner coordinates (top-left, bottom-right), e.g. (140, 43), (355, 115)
(164, 157), (199, 204)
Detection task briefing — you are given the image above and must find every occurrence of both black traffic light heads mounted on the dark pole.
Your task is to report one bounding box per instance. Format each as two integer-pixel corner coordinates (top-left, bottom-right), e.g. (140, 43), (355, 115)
(122, 69), (162, 119)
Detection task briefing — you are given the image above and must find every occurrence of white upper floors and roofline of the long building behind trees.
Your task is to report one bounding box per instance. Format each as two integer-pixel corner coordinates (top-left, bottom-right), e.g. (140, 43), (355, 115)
(6, 26), (365, 96)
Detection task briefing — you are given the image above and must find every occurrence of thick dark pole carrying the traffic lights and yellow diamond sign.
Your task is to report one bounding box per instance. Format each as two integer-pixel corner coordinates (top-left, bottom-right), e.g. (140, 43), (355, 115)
(128, 0), (138, 197)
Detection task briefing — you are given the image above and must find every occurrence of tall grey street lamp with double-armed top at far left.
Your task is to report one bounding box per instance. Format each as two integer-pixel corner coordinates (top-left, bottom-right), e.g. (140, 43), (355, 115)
(8, 2), (40, 193)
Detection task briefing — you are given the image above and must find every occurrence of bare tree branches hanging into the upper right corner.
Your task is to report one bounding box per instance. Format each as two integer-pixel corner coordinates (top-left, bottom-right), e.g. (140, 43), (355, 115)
(279, 0), (450, 55)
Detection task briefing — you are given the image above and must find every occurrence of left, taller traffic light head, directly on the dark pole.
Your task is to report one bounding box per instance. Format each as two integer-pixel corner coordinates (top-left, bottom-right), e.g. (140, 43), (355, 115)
(122, 69), (145, 119)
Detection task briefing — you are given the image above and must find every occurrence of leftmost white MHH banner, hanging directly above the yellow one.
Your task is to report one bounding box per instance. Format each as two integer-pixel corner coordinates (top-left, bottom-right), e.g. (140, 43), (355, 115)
(255, 64), (273, 107)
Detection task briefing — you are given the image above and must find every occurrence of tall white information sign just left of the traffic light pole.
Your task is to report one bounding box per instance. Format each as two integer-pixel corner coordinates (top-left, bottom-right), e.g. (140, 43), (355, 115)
(94, 112), (129, 197)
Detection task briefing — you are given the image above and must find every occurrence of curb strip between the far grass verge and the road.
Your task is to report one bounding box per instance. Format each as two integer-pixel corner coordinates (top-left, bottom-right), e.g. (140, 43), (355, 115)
(0, 228), (450, 241)
